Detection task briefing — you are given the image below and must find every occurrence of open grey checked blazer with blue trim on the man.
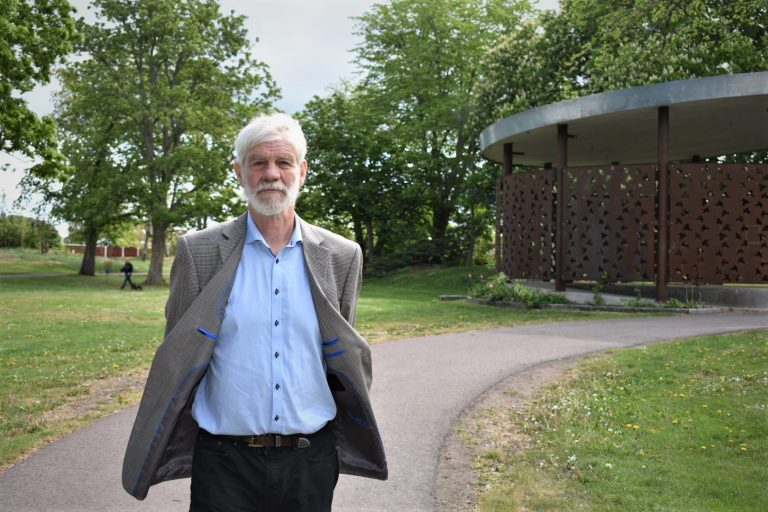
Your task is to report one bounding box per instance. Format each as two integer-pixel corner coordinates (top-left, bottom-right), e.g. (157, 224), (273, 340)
(123, 213), (387, 499)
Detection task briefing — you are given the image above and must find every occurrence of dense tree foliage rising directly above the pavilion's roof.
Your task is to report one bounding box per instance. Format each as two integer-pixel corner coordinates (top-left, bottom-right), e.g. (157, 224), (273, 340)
(481, 0), (768, 119)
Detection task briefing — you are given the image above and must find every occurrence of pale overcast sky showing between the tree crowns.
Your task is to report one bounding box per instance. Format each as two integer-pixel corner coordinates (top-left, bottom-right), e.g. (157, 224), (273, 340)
(0, 0), (558, 230)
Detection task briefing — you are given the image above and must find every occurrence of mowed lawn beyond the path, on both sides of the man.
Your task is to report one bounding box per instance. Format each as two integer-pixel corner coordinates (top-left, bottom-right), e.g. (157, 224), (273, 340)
(0, 252), (624, 467)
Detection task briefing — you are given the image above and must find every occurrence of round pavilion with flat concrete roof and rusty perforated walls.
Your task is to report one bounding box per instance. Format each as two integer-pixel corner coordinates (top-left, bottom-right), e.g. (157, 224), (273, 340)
(480, 72), (768, 301)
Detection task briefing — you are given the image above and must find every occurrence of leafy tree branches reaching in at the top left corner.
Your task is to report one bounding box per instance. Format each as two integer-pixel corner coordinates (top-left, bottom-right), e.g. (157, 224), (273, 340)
(0, 0), (79, 157)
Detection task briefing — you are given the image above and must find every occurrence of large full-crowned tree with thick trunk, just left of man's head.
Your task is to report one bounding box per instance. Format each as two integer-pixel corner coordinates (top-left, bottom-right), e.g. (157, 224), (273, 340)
(72, 0), (278, 284)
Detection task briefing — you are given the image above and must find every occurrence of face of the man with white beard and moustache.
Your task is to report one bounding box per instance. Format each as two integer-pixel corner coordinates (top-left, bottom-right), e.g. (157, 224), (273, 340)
(235, 140), (307, 216)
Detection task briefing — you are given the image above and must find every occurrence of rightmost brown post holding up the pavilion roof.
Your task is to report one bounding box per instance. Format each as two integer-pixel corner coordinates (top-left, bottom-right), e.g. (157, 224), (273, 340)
(656, 107), (669, 302)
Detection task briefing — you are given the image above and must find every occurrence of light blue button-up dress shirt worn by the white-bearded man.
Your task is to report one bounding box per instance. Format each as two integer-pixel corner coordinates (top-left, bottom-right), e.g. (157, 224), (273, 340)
(192, 215), (336, 435)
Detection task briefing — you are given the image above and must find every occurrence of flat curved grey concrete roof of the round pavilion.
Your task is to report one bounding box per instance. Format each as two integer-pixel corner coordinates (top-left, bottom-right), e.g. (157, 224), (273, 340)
(480, 71), (768, 166)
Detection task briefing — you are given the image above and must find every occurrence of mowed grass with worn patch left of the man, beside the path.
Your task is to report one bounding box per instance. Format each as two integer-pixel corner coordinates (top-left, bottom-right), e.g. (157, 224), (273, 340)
(0, 275), (167, 467)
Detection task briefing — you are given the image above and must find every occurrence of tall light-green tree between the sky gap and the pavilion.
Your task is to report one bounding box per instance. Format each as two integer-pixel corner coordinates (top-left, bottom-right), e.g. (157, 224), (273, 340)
(355, 0), (531, 261)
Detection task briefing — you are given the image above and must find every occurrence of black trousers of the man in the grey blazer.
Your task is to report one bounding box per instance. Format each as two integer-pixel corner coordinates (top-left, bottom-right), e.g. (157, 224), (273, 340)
(189, 427), (339, 512)
